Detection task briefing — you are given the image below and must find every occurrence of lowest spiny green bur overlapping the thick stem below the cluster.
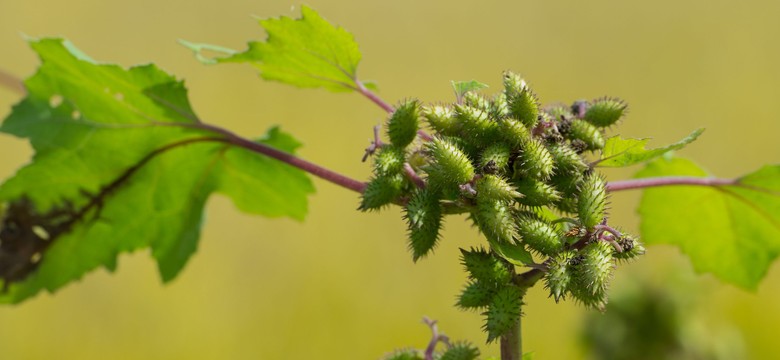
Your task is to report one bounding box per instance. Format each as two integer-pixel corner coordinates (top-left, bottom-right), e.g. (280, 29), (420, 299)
(483, 285), (523, 342)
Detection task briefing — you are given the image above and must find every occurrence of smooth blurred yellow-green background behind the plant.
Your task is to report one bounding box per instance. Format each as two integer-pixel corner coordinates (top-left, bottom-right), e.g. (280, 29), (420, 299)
(0, 0), (780, 359)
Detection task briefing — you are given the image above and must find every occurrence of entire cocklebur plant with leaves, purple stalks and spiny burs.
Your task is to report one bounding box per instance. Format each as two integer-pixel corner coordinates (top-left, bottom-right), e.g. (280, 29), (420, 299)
(0, 7), (780, 359)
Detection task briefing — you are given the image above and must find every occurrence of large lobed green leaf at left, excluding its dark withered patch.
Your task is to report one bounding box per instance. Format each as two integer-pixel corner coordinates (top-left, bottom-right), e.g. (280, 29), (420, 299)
(0, 39), (313, 302)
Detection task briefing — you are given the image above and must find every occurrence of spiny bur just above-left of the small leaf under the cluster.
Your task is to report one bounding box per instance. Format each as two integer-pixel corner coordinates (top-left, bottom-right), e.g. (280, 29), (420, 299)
(472, 197), (518, 243)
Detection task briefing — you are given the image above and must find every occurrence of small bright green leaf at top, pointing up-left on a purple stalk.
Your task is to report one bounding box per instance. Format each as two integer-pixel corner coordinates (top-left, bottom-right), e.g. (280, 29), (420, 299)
(181, 6), (365, 92)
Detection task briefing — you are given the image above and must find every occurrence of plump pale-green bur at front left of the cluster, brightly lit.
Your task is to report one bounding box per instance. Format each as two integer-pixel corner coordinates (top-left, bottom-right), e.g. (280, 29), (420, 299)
(428, 137), (474, 188)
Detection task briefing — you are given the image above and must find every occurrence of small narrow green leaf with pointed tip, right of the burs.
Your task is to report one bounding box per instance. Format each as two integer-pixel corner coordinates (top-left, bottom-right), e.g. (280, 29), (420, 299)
(598, 128), (704, 167)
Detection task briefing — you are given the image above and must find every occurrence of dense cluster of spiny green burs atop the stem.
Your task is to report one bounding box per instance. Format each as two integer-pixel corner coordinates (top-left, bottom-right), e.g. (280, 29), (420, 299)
(360, 72), (643, 340)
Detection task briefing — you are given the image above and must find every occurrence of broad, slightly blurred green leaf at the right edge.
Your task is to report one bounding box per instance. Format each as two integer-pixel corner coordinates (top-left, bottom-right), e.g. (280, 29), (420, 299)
(637, 158), (780, 290)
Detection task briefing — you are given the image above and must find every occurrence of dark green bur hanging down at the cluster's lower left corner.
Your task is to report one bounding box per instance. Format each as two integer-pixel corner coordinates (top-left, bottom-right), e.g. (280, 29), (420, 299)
(404, 189), (442, 261)
